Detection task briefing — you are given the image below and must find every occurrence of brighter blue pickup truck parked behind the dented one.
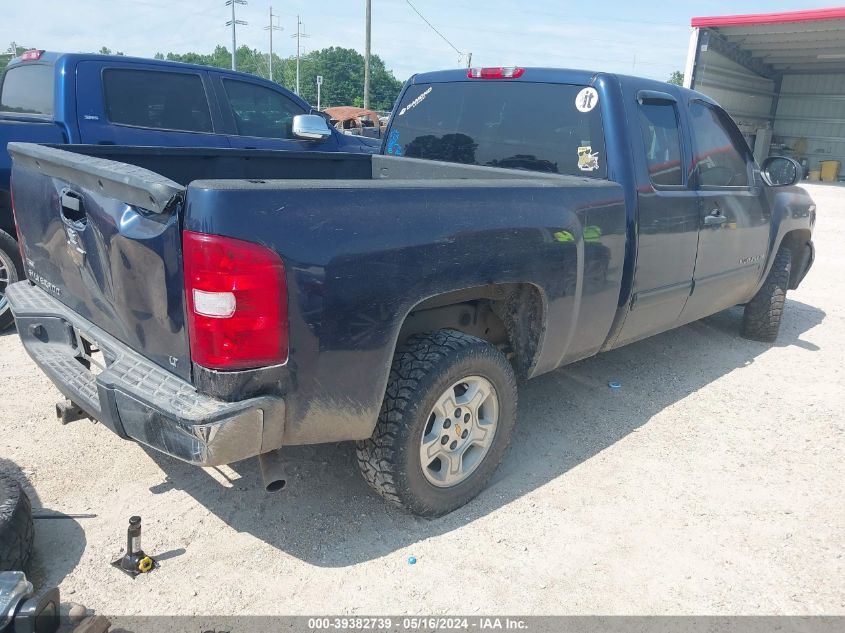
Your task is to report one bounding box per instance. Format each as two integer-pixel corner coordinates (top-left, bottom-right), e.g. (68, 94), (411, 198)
(0, 51), (381, 329)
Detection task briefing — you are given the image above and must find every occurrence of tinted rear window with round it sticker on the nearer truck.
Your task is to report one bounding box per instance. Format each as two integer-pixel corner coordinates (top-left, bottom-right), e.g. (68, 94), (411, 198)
(387, 80), (607, 178)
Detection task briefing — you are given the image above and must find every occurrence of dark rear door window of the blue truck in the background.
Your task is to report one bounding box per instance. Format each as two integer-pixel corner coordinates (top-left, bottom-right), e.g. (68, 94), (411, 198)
(103, 68), (213, 132)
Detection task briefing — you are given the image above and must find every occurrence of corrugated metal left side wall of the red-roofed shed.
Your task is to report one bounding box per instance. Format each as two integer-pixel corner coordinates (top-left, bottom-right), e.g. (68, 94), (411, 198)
(693, 50), (774, 137)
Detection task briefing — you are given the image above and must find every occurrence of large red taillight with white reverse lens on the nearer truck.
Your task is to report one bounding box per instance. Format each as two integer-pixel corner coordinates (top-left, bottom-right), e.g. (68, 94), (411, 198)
(182, 231), (288, 369)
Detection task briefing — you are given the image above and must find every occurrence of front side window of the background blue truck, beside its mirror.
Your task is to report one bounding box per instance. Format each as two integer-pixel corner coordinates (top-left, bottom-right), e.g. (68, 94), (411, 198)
(223, 79), (305, 138)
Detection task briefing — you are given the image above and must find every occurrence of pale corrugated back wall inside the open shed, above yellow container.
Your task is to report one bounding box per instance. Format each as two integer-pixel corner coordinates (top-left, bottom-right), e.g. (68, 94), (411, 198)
(773, 73), (845, 169)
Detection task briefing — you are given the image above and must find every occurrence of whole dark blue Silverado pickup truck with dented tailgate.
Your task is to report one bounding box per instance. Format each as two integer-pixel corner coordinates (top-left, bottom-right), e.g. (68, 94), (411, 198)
(7, 68), (815, 516)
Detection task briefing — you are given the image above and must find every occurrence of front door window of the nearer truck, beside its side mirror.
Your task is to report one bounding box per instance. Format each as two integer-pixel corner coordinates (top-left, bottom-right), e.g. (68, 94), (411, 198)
(689, 101), (750, 187)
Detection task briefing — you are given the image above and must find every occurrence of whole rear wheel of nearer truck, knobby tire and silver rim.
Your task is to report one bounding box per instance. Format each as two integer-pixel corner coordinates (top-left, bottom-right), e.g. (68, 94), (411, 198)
(357, 330), (517, 517)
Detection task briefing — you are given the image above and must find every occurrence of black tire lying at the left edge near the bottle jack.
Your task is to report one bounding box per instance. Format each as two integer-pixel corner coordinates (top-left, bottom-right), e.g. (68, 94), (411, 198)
(0, 473), (35, 571)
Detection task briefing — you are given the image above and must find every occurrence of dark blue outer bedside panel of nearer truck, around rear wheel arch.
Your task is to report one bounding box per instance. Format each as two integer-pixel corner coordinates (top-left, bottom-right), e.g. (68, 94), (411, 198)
(184, 170), (625, 443)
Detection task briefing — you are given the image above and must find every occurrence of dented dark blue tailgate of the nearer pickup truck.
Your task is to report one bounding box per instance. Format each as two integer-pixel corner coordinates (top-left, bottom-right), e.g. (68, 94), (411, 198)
(9, 143), (191, 380)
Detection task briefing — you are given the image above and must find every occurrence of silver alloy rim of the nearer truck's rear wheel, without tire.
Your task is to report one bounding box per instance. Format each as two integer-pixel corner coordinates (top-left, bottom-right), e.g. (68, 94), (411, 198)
(420, 376), (499, 488)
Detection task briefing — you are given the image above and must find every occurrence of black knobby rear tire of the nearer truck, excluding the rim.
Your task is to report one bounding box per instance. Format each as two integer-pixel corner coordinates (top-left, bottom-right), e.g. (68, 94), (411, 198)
(356, 330), (517, 517)
